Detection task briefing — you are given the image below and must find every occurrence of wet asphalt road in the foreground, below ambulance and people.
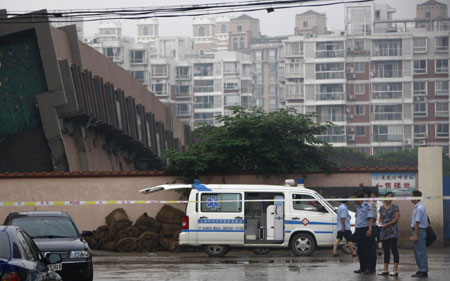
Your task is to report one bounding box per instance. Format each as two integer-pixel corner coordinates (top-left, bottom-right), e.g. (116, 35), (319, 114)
(94, 248), (450, 281)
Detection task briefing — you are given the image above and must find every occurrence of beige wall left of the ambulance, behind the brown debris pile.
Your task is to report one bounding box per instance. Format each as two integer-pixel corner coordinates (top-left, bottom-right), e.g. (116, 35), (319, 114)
(0, 176), (184, 230)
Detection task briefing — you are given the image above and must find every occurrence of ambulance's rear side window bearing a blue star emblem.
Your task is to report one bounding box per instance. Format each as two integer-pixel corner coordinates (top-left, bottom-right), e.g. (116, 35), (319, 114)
(201, 193), (242, 213)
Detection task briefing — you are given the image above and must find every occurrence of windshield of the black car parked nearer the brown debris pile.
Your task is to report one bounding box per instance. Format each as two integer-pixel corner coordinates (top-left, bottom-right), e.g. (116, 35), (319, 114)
(11, 217), (78, 238)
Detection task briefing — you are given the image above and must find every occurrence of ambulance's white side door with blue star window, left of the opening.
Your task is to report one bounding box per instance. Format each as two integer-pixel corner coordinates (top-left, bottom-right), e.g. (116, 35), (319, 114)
(198, 192), (244, 245)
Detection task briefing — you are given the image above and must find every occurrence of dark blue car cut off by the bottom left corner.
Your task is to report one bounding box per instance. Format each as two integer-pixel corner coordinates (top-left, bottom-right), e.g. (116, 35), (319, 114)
(0, 225), (62, 281)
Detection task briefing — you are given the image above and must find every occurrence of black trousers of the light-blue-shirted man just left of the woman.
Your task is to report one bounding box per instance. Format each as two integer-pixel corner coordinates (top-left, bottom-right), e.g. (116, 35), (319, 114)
(355, 227), (377, 272)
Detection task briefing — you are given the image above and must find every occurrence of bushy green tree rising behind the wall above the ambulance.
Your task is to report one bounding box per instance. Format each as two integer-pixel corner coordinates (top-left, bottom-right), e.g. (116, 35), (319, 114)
(165, 108), (333, 181)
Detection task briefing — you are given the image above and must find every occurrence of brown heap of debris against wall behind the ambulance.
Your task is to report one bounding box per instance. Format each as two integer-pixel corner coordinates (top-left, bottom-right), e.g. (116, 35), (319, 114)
(84, 205), (184, 252)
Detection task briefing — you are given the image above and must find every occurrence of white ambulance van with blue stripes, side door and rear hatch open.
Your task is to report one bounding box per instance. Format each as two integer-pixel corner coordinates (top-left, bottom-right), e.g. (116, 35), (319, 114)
(141, 179), (355, 256)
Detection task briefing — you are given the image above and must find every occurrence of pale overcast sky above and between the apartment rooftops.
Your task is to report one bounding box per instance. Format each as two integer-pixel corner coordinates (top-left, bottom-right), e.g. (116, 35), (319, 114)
(0, 0), (442, 37)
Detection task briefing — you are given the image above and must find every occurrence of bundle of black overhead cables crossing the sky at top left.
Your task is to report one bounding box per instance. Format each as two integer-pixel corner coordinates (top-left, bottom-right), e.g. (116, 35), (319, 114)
(0, 0), (374, 23)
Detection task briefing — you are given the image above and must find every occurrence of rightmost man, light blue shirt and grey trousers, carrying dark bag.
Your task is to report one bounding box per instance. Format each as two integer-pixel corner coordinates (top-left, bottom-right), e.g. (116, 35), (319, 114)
(410, 190), (428, 277)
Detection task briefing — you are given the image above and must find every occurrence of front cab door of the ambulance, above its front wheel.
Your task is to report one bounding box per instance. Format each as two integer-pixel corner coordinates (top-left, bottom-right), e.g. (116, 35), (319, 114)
(286, 192), (335, 246)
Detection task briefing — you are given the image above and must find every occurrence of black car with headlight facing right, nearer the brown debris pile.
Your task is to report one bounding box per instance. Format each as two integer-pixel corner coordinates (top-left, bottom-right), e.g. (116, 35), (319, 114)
(4, 211), (93, 281)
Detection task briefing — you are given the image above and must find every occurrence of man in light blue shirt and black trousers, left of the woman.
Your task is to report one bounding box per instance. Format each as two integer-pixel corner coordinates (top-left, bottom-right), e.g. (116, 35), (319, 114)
(353, 191), (377, 274)
